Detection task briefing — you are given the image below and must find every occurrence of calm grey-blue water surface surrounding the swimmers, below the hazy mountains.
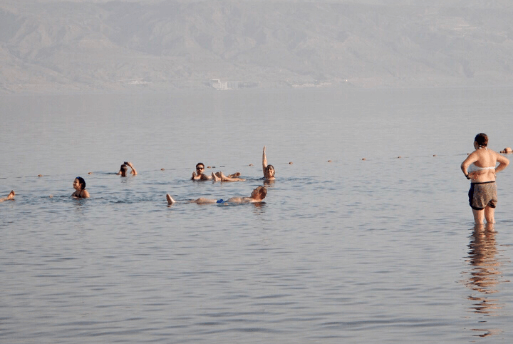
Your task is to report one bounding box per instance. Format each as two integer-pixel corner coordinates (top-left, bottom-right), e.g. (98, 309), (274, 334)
(0, 89), (513, 343)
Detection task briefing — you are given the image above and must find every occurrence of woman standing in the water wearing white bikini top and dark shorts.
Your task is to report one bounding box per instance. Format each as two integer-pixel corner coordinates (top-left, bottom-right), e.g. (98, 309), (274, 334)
(461, 133), (509, 225)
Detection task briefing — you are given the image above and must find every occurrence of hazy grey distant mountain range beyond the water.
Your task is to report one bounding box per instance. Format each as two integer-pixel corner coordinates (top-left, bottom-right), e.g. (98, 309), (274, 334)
(0, 0), (513, 93)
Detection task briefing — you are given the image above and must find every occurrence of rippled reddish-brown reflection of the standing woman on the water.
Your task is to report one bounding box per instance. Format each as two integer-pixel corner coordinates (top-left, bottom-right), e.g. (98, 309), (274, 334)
(465, 225), (507, 337)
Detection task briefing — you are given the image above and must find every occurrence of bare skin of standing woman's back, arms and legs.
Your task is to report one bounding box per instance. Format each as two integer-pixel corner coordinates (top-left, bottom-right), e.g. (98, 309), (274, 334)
(461, 142), (509, 224)
